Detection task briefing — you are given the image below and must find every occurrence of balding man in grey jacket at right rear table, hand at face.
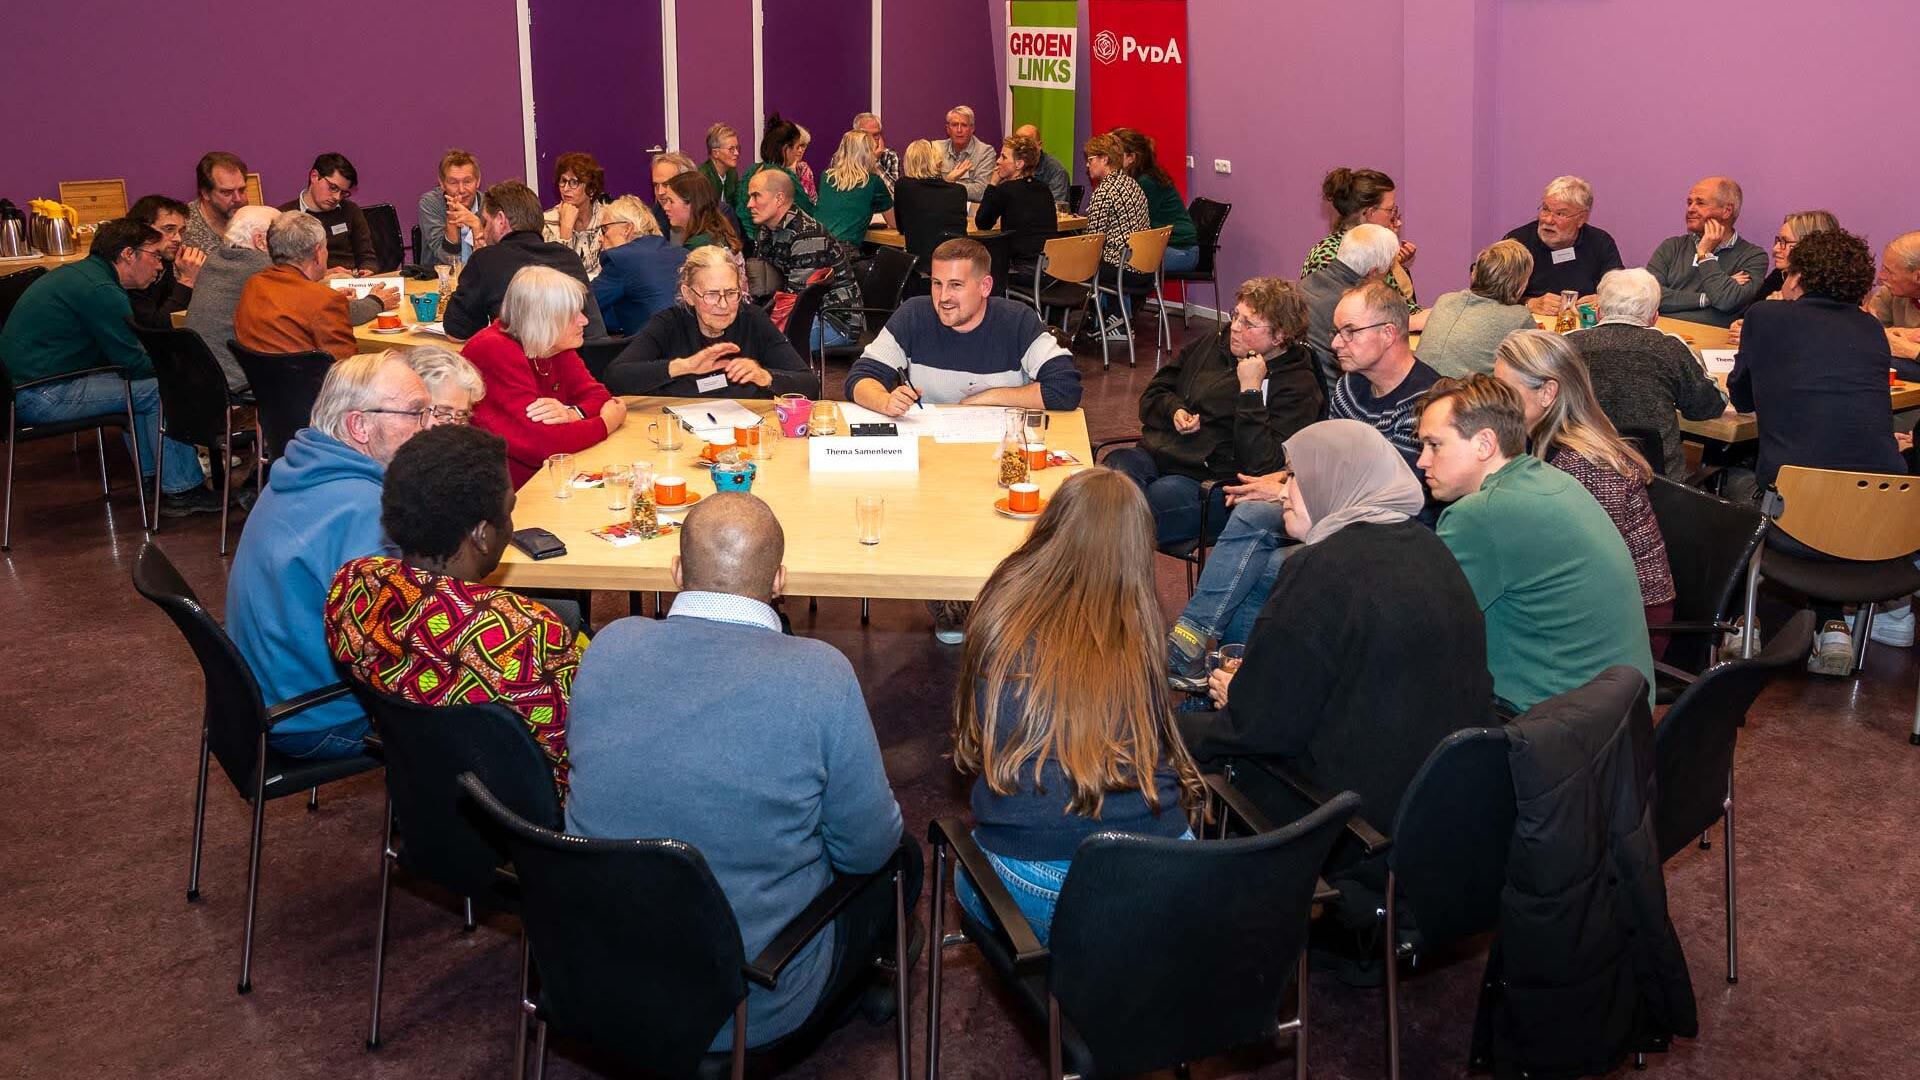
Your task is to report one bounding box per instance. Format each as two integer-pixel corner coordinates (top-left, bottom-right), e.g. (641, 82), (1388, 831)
(1647, 177), (1766, 327)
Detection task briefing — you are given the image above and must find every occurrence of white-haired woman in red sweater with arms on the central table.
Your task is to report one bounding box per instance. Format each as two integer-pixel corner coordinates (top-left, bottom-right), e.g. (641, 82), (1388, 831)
(461, 267), (626, 488)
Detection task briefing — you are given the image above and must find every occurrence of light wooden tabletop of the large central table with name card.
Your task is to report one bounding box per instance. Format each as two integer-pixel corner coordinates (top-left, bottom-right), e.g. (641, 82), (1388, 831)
(490, 398), (1092, 600)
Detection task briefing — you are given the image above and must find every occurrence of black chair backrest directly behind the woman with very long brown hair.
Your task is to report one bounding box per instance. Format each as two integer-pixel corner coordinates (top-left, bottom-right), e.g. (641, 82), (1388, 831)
(1046, 792), (1359, 1074)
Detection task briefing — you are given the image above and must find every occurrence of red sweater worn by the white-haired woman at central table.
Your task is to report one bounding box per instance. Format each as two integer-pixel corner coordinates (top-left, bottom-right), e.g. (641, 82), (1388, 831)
(461, 323), (612, 488)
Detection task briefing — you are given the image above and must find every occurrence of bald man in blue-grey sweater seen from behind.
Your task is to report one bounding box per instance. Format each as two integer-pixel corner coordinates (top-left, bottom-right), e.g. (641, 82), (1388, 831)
(566, 492), (920, 1049)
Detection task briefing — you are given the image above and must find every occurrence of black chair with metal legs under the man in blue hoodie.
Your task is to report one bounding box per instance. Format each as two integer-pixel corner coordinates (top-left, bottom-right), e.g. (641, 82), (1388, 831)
(132, 540), (380, 994)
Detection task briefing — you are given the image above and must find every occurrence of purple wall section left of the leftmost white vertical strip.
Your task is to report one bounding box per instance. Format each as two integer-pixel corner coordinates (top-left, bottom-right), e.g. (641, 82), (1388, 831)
(0, 0), (524, 237)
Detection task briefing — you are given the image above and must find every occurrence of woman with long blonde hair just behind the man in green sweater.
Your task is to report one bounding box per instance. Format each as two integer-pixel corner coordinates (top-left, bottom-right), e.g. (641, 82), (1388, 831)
(1494, 331), (1674, 641)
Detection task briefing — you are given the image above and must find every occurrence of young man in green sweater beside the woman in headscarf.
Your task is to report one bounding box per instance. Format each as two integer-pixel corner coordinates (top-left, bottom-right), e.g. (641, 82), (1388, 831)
(1413, 374), (1653, 711)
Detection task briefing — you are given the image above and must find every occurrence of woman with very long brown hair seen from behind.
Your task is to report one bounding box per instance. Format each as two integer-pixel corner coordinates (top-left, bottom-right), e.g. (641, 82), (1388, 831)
(954, 469), (1204, 942)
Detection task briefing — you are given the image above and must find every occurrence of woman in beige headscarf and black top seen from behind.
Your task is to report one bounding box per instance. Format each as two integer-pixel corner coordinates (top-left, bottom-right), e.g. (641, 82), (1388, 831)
(1179, 421), (1494, 880)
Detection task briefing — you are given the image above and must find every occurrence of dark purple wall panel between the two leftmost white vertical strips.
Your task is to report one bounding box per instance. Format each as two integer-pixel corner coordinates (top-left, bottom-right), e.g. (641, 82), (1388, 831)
(533, 0), (666, 197)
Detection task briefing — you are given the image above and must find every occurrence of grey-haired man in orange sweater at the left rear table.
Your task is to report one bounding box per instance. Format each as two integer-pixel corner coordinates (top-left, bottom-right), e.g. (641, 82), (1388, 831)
(234, 209), (399, 359)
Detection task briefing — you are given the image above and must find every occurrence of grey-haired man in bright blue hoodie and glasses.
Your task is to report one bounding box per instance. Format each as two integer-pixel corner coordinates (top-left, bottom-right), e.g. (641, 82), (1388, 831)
(227, 352), (434, 757)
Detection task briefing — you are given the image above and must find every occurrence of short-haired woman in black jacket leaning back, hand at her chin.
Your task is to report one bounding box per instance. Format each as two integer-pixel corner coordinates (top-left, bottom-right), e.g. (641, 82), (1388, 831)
(1106, 277), (1323, 544)
